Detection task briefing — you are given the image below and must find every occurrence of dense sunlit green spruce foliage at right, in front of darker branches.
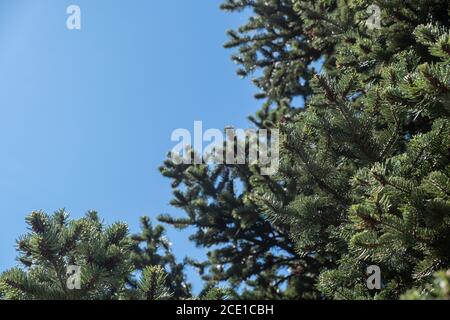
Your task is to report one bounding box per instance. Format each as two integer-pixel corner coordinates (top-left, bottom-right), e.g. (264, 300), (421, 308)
(258, 1), (450, 299)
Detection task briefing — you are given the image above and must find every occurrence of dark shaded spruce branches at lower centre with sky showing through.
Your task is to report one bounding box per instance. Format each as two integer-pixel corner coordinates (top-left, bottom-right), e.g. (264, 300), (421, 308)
(159, 156), (310, 299)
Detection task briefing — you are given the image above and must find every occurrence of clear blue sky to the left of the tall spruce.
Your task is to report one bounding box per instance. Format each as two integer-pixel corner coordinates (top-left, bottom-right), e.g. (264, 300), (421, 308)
(0, 0), (259, 290)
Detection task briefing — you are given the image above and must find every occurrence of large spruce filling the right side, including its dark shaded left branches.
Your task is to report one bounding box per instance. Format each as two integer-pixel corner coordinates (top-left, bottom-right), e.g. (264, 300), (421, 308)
(161, 0), (450, 299)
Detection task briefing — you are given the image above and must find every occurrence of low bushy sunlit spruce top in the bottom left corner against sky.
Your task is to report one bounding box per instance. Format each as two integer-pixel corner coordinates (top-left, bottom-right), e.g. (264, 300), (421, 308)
(0, 210), (132, 300)
